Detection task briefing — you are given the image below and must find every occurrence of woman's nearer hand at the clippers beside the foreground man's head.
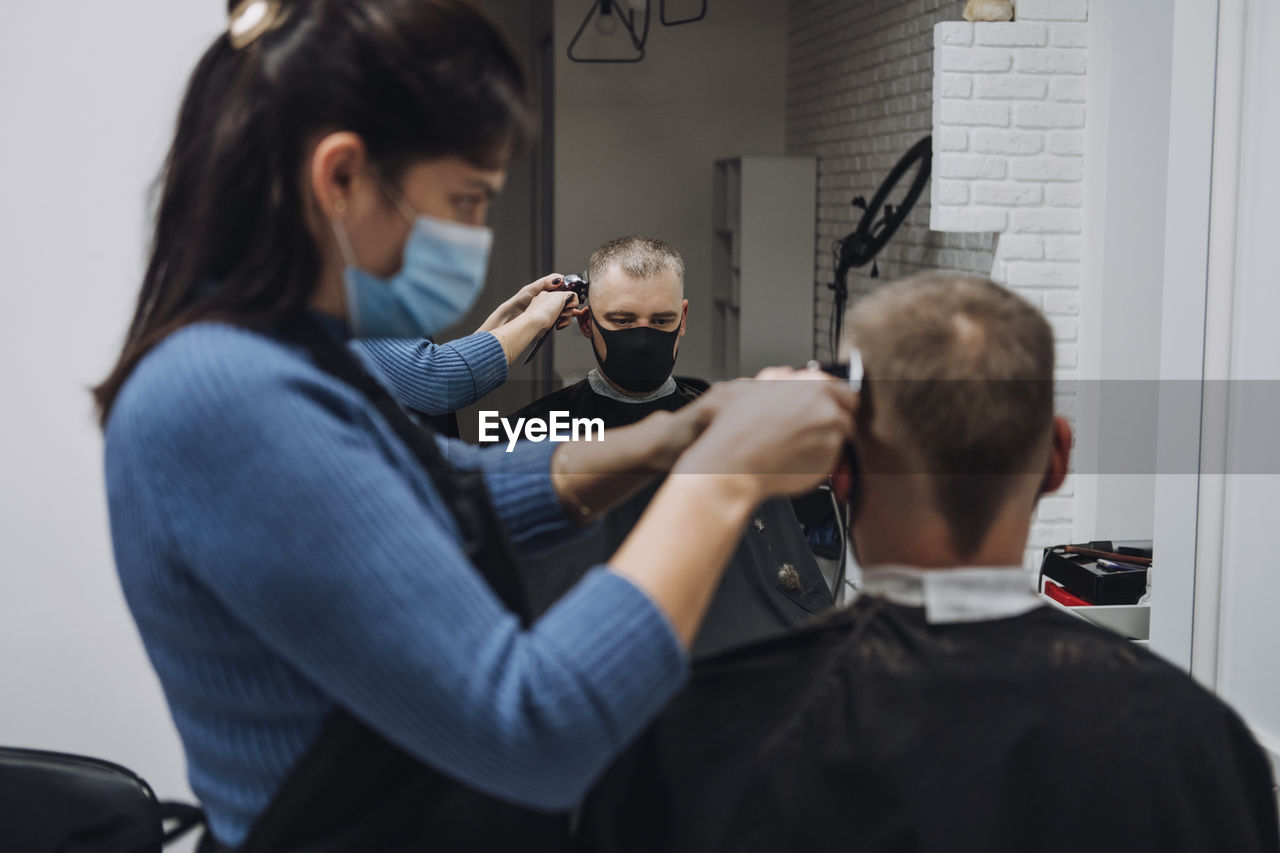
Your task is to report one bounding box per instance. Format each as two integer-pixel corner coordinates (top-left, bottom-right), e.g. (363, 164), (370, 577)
(672, 368), (858, 502)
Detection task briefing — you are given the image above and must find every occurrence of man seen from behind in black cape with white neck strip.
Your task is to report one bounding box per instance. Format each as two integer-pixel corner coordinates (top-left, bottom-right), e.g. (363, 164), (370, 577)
(580, 274), (1280, 853)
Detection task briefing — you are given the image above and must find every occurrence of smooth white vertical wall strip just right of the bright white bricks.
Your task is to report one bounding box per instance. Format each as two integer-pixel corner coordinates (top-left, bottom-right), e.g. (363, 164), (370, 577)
(1076, 0), (1172, 539)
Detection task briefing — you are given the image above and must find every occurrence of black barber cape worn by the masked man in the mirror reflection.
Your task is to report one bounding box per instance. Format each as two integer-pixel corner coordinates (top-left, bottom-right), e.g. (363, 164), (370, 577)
(499, 377), (833, 656)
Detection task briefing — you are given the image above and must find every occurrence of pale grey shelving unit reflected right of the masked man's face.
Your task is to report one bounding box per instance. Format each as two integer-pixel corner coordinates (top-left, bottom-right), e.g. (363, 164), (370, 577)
(712, 158), (817, 378)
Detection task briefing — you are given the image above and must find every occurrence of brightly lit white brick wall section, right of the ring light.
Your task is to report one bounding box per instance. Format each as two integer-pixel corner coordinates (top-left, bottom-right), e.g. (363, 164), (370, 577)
(931, 0), (1088, 566)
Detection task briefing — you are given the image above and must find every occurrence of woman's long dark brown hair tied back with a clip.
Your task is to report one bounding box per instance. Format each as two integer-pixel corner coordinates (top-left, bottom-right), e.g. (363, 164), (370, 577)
(93, 0), (531, 424)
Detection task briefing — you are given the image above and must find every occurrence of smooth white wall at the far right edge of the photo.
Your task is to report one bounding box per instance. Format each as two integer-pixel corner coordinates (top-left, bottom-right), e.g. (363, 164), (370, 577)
(1151, 0), (1280, 798)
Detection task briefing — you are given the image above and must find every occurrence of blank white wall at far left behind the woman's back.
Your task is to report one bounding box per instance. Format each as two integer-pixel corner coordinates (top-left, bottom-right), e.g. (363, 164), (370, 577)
(0, 0), (223, 814)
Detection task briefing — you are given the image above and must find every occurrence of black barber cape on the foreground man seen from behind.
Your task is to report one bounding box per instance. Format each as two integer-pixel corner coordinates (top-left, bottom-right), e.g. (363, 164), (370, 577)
(577, 596), (1280, 853)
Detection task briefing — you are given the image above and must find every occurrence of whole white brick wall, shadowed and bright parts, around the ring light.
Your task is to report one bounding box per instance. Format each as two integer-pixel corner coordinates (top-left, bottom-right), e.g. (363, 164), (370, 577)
(787, 0), (1088, 566)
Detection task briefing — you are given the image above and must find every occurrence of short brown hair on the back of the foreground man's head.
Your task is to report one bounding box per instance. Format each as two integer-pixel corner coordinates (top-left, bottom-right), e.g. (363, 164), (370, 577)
(850, 273), (1053, 558)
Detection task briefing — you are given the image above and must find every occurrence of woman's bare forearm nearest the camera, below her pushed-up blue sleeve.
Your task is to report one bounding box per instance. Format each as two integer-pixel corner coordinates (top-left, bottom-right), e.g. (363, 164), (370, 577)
(609, 474), (759, 648)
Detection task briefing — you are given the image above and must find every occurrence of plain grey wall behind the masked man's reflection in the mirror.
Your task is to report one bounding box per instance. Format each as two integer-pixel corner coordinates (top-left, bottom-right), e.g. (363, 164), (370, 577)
(556, 0), (788, 379)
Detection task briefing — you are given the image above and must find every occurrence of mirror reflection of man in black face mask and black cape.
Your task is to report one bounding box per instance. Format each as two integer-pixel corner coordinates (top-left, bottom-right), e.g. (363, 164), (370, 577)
(499, 237), (833, 654)
